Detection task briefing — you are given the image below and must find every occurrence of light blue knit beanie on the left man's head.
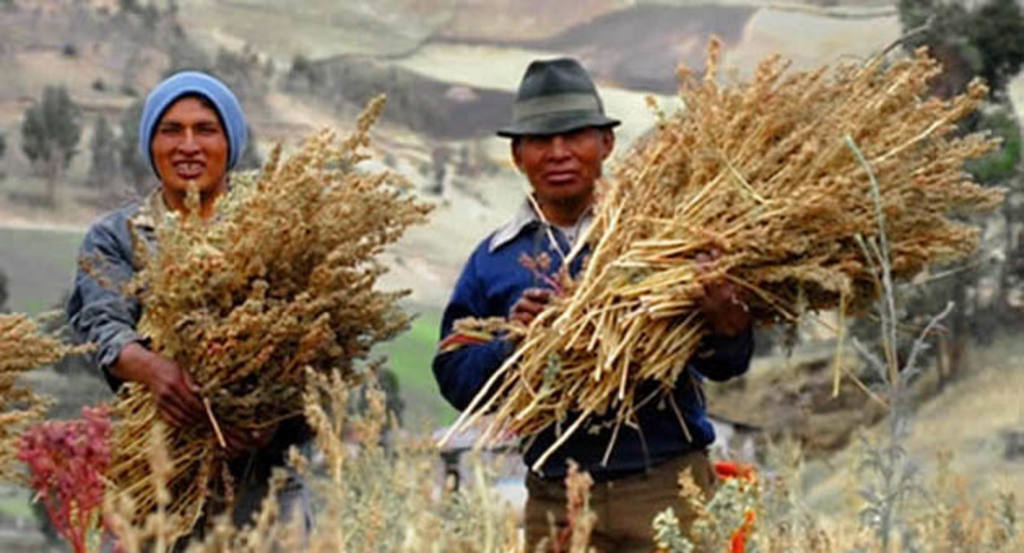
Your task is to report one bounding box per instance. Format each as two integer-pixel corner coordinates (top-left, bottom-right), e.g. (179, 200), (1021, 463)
(138, 71), (248, 178)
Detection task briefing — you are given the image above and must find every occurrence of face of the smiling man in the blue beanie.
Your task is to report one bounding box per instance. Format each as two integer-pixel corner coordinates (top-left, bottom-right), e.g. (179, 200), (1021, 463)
(150, 97), (227, 194)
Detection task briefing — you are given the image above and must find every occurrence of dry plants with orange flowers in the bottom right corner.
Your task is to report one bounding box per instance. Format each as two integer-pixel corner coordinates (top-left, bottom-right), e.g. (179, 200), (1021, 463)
(654, 452), (1024, 553)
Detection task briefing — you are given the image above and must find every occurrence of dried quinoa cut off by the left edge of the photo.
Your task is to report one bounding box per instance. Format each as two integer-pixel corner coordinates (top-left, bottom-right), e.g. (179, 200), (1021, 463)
(0, 313), (86, 481)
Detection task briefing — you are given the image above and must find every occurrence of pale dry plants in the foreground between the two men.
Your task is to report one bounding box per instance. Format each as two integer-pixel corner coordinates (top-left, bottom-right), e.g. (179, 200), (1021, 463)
(304, 366), (522, 553)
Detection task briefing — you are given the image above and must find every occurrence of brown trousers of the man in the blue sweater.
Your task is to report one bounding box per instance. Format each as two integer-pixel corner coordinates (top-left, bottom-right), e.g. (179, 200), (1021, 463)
(524, 451), (715, 553)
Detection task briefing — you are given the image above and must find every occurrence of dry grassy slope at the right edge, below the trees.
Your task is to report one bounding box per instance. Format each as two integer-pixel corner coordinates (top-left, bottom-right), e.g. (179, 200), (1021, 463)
(803, 337), (1024, 512)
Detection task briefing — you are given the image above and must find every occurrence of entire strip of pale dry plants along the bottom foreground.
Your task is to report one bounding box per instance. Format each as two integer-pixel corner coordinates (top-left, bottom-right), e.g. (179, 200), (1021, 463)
(90, 364), (1024, 553)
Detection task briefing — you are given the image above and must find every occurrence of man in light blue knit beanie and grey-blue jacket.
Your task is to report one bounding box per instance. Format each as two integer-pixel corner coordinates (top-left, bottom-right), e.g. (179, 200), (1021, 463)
(67, 71), (311, 550)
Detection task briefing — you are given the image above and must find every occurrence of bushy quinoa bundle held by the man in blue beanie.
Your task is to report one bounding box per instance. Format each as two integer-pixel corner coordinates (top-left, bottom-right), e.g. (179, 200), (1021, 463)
(109, 97), (430, 535)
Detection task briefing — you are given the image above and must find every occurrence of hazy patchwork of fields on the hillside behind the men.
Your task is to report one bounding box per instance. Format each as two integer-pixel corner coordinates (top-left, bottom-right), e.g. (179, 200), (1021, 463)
(0, 0), (913, 305)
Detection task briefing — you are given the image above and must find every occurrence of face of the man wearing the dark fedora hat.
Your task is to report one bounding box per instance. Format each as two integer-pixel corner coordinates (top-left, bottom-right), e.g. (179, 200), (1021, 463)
(512, 127), (615, 203)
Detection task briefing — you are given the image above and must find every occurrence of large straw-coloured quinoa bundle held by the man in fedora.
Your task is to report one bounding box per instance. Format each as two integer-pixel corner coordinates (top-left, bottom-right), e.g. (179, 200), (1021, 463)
(444, 42), (1004, 467)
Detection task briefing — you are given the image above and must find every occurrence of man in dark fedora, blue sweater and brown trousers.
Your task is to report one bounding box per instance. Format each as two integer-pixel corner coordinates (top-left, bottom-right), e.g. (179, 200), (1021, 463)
(433, 58), (754, 553)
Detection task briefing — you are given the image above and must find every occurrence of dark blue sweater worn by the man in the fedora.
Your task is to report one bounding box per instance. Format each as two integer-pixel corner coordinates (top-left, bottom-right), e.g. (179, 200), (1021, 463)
(433, 211), (754, 481)
